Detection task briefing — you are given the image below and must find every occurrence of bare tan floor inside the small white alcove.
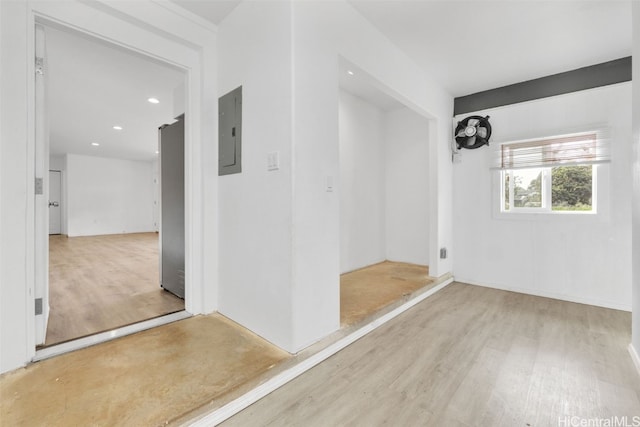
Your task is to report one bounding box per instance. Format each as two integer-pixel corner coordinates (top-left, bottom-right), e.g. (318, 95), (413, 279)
(340, 261), (434, 326)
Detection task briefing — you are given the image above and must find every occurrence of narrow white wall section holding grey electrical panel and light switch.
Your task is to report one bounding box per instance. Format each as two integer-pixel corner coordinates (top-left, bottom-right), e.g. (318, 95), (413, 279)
(218, 2), (292, 350)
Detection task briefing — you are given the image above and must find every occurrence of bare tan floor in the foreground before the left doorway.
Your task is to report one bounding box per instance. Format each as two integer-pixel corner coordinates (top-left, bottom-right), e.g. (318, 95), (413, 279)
(0, 315), (289, 426)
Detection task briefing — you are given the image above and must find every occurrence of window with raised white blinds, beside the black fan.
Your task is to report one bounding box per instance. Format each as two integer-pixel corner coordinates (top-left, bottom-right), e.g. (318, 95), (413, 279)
(498, 132), (609, 213)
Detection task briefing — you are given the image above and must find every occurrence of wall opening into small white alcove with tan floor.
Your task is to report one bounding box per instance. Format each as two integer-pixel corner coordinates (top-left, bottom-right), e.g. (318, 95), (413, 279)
(338, 58), (435, 326)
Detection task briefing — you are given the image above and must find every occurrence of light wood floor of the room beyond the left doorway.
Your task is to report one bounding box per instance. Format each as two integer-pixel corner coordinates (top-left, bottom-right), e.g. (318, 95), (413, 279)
(45, 233), (184, 346)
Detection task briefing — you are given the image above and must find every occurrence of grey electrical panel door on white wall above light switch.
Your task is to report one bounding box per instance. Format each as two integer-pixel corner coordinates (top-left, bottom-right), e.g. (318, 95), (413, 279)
(218, 86), (242, 175)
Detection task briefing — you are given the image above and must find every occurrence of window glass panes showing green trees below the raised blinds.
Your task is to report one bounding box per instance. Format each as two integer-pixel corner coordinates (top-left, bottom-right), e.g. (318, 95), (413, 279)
(503, 165), (593, 211)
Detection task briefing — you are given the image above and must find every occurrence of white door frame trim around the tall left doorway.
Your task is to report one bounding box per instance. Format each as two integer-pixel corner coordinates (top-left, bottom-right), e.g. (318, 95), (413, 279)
(24, 1), (218, 362)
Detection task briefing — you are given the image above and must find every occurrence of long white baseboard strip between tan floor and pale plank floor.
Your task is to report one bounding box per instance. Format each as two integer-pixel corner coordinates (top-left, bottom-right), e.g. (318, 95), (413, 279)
(184, 278), (453, 427)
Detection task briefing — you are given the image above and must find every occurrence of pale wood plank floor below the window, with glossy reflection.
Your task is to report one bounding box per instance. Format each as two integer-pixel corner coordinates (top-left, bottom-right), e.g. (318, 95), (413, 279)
(223, 283), (640, 427)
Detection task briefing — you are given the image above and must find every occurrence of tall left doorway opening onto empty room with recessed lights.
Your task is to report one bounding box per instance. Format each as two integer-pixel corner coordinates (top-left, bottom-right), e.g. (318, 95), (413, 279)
(36, 24), (186, 350)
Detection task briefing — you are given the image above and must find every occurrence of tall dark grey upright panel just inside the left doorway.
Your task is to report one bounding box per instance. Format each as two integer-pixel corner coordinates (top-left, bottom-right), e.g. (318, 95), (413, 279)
(159, 115), (185, 298)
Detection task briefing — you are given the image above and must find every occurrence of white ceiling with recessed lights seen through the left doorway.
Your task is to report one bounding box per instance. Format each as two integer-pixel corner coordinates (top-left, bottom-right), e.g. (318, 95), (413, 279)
(45, 27), (185, 161)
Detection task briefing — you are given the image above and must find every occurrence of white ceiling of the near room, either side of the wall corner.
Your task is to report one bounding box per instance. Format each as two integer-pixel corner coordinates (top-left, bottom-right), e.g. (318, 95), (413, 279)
(173, 0), (631, 97)
